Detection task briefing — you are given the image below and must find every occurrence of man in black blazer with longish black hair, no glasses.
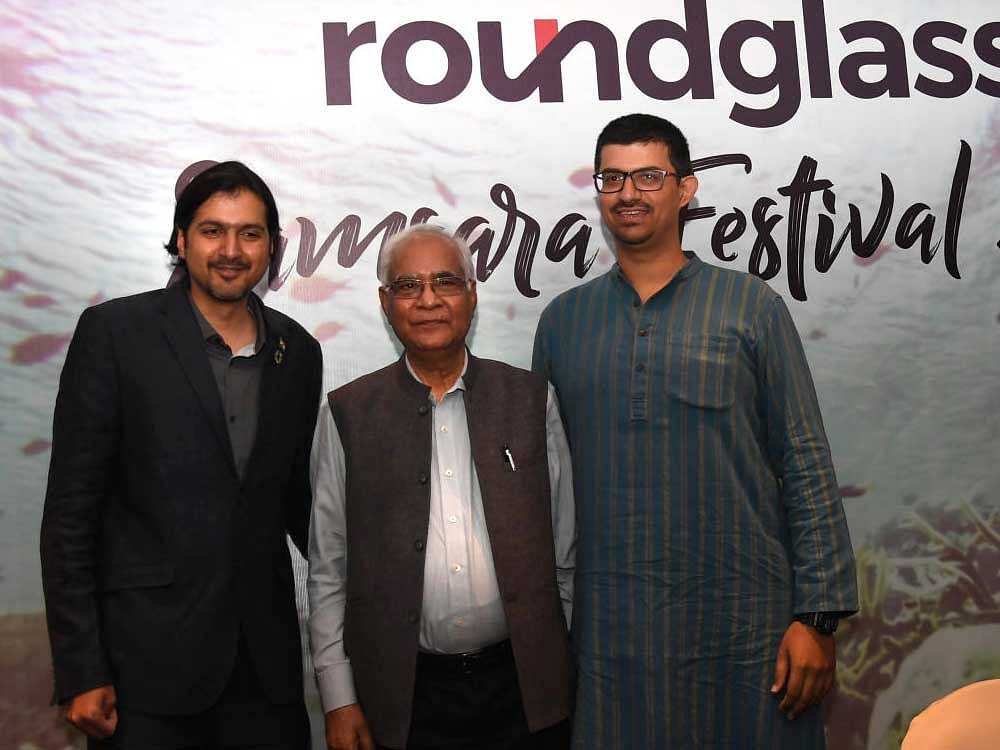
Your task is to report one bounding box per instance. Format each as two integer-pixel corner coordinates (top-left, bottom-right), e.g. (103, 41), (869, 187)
(41, 162), (322, 750)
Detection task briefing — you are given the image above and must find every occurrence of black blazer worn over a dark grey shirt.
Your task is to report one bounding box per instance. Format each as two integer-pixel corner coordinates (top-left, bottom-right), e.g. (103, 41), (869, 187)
(41, 283), (322, 714)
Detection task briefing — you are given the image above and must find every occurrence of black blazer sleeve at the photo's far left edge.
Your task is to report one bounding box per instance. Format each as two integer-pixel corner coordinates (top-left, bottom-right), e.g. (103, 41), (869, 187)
(40, 308), (120, 702)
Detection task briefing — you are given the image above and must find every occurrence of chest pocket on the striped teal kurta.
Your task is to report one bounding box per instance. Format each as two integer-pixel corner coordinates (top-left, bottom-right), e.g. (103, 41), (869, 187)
(667, 334), (736, 409)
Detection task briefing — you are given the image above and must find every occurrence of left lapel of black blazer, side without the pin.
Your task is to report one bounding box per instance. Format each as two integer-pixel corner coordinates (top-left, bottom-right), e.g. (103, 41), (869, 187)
(162, 284), (236, 475)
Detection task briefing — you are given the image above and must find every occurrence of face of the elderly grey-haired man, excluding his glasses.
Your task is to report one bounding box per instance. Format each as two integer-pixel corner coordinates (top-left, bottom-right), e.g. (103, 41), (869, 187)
(379, 234), (476, 355)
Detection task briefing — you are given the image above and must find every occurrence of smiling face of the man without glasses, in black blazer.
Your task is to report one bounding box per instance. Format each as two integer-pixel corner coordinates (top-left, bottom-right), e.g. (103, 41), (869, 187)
(177, 190), (271, 309)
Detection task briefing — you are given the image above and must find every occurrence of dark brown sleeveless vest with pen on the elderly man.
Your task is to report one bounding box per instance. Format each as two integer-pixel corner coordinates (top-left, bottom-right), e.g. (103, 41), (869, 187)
(329, 355), (573, 747)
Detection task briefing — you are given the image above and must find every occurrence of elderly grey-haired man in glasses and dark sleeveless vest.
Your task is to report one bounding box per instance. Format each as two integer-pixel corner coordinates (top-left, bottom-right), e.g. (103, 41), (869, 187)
(309, 226), (574, 750)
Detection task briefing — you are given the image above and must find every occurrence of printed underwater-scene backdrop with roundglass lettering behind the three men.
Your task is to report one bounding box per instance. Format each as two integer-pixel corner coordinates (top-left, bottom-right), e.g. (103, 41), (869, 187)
(0, 0), (1000, 750)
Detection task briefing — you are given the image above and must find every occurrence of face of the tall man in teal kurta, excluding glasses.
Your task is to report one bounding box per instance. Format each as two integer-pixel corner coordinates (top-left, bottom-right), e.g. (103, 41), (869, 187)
(598, 142), (698, 253)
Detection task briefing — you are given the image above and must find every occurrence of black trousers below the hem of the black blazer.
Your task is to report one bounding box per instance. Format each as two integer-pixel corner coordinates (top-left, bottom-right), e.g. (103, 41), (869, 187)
(87, 634), (310, 750)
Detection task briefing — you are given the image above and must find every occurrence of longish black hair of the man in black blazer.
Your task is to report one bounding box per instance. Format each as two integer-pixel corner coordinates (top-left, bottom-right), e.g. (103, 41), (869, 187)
(164, 161), (281, 265)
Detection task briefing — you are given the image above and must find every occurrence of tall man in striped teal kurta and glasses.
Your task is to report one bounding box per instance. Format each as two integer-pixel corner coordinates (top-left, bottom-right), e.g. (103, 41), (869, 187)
(534, 115), (857, 750)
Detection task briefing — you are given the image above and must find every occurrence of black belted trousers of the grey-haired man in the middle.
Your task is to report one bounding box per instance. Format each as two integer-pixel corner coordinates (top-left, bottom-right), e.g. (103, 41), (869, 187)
(378, 642), (570, 750)
